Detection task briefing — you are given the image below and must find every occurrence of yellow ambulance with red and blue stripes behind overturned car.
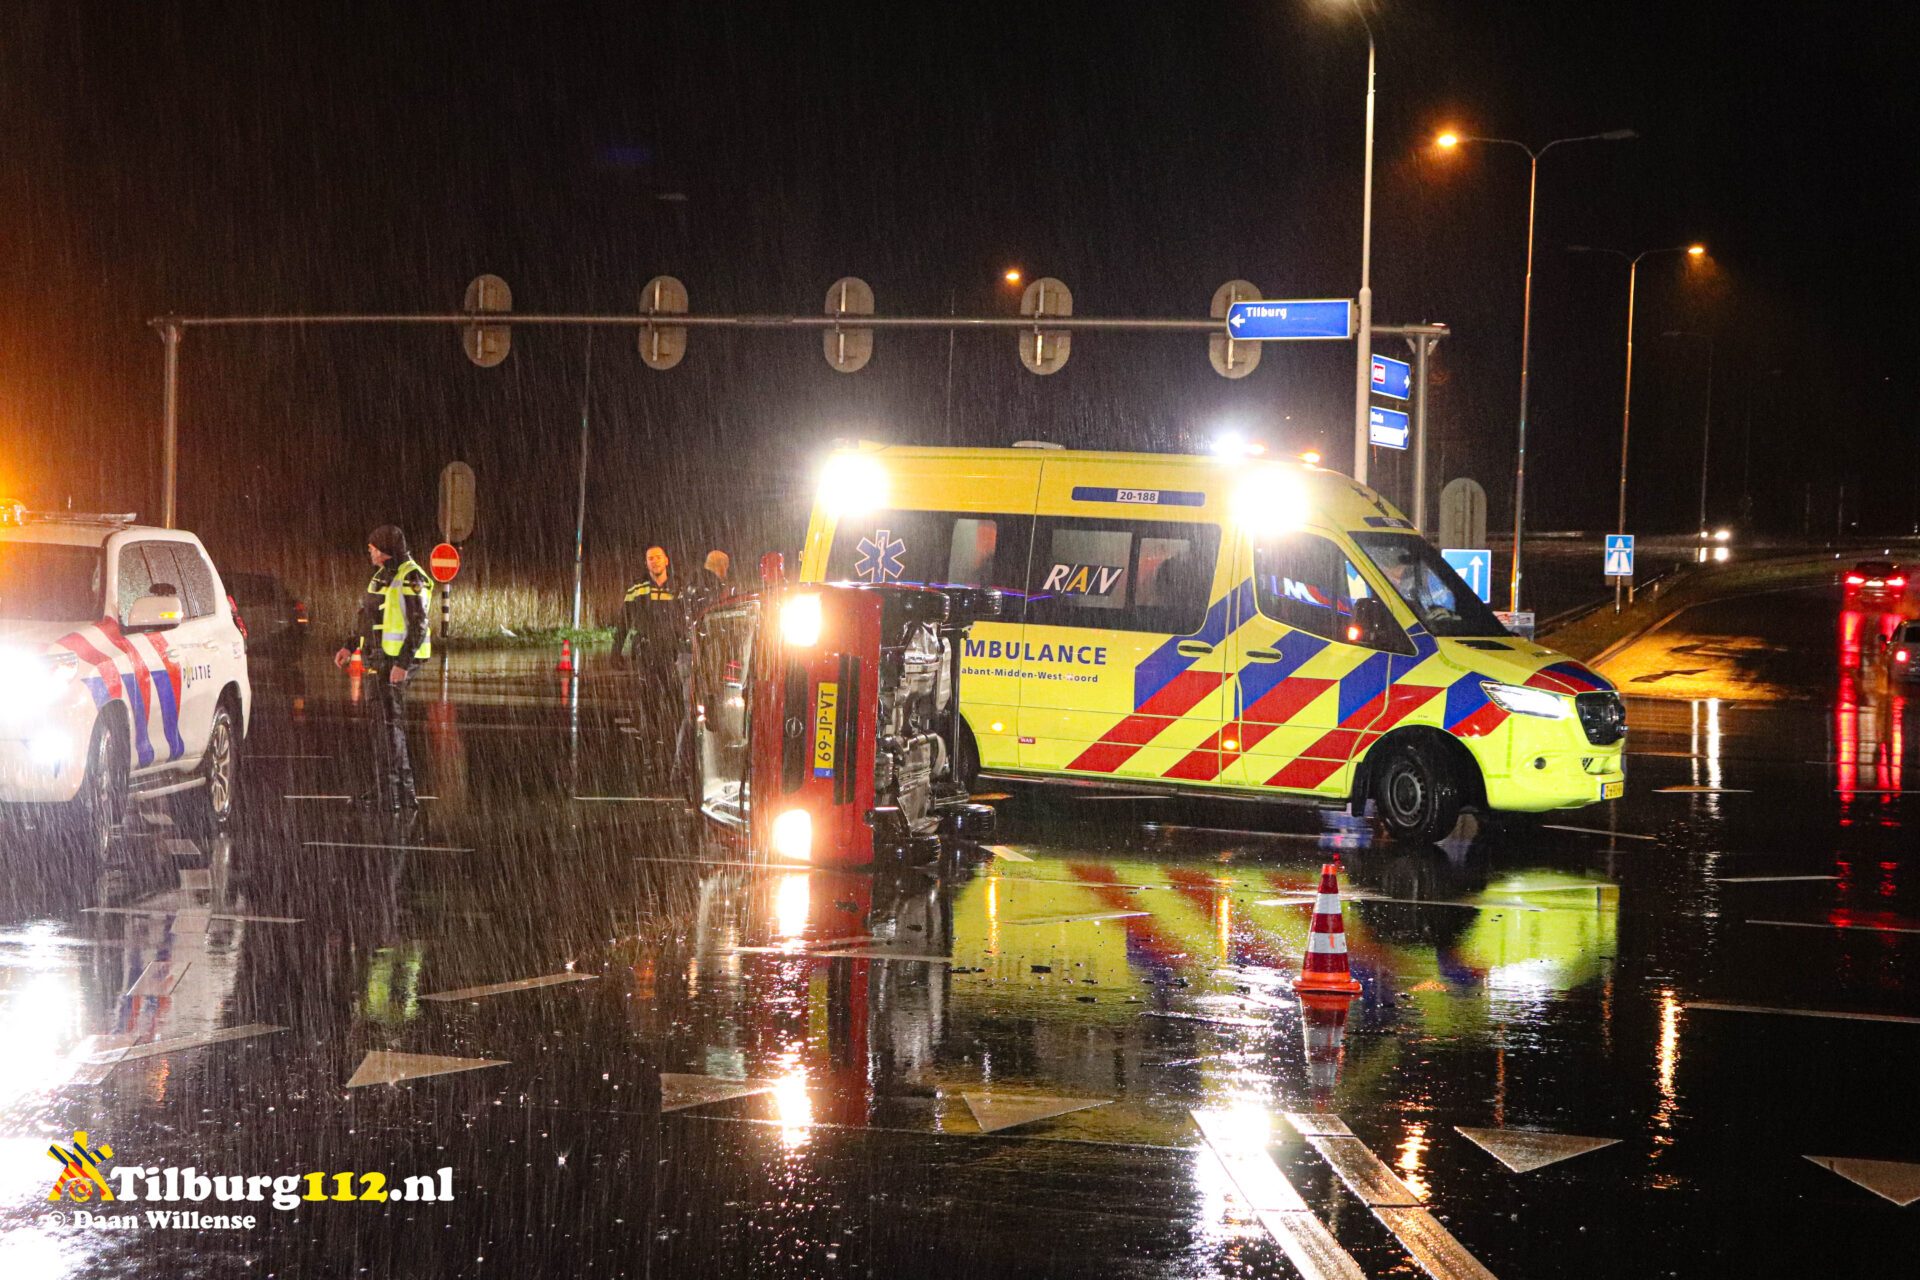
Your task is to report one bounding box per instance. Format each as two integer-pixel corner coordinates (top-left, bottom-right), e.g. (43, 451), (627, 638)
(801, 441), (1626, 842)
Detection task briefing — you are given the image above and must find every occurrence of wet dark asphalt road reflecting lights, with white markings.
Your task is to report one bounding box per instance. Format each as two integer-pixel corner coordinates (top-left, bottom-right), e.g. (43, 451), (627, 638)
(0, 589), (1920, 1276)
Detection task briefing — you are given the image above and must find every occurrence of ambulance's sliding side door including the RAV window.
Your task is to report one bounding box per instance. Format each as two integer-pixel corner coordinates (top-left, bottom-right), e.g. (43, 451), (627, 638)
(1016, 512), (1229, 783)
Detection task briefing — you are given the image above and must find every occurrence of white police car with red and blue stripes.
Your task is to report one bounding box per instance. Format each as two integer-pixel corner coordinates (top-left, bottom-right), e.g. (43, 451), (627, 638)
(0, 503), (253, 856)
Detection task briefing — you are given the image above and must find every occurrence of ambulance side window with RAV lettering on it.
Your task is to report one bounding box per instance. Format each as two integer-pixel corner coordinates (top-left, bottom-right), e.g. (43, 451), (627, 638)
(1027, 520), (1219, 635)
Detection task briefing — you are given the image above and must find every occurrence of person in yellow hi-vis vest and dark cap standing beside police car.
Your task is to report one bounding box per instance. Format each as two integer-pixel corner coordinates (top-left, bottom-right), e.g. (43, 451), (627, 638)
(334, 524), (434, 812)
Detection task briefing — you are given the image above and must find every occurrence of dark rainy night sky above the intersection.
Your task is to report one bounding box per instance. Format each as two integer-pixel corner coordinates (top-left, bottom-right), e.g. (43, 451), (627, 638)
(0, 0), (1920, 587)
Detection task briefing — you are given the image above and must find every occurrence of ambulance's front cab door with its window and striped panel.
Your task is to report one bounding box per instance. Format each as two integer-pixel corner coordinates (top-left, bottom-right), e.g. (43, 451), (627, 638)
(1225, 530), (1392, 796)
